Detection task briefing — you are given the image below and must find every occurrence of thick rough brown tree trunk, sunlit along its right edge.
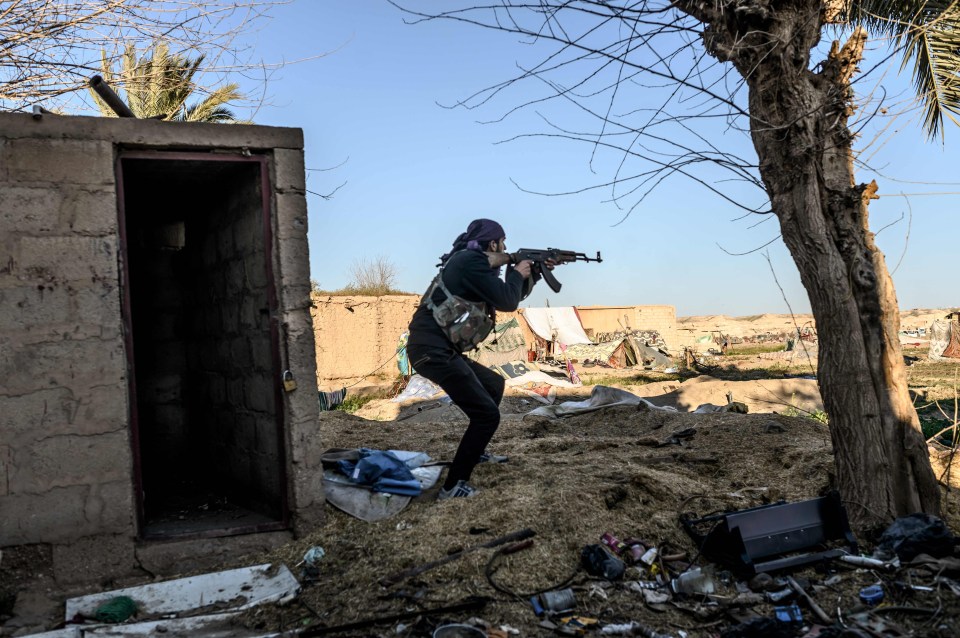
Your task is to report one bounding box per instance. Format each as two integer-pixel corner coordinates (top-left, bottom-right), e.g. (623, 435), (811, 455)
(690, 0), (940, 530)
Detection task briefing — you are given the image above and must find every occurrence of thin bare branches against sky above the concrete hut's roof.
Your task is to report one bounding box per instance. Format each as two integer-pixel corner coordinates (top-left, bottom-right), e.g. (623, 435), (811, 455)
(0, 0), (284, 109)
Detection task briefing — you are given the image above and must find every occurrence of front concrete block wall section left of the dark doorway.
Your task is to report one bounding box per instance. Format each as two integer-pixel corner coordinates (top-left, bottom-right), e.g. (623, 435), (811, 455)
(0, 130), (134, 546)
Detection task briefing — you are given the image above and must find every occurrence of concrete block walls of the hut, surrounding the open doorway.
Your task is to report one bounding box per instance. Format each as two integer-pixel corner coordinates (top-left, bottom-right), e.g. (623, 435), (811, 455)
(0, 113), (324, 582)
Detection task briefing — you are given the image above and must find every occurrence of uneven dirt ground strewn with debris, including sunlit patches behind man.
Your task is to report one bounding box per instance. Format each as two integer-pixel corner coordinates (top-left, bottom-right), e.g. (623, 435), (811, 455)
(7, 362), (960, 638)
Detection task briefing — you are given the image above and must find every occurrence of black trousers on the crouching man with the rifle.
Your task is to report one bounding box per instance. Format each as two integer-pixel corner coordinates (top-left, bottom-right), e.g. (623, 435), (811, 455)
(407, 345), (504, 489)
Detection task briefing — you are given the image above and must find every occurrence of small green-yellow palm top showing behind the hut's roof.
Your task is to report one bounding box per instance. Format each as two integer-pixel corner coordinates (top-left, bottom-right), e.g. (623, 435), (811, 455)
(91, 42), (243, 123)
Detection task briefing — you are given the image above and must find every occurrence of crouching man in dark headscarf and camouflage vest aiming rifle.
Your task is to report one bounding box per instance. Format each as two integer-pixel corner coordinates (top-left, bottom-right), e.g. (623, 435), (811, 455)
(407, 219), (549, 500)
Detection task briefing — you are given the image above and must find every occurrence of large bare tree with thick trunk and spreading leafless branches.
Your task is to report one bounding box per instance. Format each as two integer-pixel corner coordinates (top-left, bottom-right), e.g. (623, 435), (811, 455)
(397, 0), (960, 529)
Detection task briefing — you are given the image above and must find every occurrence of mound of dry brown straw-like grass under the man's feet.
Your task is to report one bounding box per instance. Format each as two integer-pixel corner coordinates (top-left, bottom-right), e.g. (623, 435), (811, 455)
(232, 408), (936, 636)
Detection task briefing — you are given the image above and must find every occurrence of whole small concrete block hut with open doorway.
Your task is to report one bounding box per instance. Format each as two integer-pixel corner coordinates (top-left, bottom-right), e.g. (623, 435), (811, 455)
(0, 113), (324, 582)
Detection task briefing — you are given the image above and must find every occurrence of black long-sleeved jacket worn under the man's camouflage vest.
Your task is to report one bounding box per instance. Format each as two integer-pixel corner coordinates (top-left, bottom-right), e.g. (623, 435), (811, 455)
(407, 250), (533, 348)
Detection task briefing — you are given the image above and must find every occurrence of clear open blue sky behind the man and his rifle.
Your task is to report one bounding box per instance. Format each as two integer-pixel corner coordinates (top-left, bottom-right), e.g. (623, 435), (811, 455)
(234, 0), (960, 315)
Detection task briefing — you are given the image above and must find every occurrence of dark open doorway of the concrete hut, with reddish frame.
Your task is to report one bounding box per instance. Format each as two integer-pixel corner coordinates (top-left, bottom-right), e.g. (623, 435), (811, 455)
(117, 152), (287, 538)
